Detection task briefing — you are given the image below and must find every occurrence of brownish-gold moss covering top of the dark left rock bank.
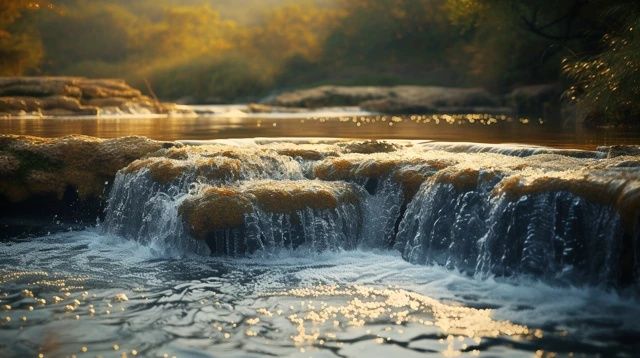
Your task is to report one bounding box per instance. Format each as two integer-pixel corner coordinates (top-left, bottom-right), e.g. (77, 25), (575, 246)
(0, 135), (172, 202)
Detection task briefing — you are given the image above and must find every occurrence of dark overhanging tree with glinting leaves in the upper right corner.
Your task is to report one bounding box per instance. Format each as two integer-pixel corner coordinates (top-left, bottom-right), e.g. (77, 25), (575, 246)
(447, 0), (640, 123)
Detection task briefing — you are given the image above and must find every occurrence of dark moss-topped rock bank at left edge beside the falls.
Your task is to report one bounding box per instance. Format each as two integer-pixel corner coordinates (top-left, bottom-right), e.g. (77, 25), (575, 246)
(0, 135), (176, 235)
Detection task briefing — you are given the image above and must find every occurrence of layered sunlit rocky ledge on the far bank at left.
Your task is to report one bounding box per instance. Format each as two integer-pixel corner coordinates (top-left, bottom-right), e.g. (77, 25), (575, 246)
(0, 77), (193, 117)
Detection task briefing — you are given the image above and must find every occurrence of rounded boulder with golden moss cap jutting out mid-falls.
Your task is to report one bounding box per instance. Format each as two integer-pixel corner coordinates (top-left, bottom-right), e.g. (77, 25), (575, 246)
(179, 180), (361, 253)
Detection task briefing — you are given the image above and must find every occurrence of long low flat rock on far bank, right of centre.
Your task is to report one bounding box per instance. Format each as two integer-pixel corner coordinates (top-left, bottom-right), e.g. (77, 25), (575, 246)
(268, 86), (500, 114)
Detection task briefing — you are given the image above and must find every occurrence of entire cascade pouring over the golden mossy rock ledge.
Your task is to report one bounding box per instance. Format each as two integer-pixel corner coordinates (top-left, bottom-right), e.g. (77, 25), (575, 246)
(102, 142), (640, 286)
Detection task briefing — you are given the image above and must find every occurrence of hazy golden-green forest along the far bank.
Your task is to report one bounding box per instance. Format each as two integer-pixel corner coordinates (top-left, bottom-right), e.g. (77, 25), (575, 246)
(0, 0), (640, 124)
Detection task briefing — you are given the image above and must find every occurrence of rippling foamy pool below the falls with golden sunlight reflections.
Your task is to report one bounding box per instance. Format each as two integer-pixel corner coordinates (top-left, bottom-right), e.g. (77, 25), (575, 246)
(0, 230), (640, 357)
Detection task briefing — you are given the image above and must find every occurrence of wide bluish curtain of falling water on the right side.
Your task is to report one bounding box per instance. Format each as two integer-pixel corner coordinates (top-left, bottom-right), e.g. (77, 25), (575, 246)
(395, 182), (637, 284)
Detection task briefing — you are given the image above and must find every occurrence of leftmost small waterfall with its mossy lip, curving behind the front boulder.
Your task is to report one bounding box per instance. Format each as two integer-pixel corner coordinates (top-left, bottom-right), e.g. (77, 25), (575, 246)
(101, 146), (303, 254)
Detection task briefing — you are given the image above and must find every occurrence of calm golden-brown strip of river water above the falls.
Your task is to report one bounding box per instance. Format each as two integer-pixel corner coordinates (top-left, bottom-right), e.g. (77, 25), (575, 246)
(0, 106), (640, 149)
